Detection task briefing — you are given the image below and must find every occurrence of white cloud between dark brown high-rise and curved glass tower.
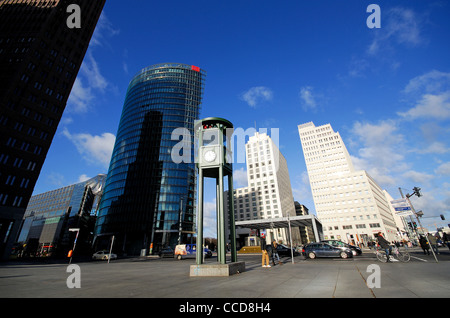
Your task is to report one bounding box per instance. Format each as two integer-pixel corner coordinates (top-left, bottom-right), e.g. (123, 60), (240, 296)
(63, 128), (116, 169)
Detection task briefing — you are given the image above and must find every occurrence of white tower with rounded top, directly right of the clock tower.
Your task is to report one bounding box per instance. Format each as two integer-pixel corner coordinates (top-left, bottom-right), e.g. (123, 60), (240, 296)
(226, 132), (300, 245)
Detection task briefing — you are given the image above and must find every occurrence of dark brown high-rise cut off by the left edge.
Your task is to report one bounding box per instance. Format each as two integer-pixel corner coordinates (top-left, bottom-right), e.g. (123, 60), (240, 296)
(0, 0), (105, 259)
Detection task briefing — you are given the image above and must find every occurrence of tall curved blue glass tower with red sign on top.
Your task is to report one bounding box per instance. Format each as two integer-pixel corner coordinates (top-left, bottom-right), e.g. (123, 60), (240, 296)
(95, 63), (206, 255)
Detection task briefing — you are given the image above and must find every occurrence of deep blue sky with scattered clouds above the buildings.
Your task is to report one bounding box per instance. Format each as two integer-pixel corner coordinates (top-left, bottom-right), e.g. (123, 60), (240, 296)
(34, 0), (450, 236)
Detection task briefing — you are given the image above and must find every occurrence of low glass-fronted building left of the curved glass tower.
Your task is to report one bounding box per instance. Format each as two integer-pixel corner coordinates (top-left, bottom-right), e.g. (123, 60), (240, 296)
(14, 174), (106, 257)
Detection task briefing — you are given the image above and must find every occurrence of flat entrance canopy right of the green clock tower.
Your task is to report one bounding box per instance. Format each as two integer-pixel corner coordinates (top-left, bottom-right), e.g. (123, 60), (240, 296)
(236, 214), (323, 242)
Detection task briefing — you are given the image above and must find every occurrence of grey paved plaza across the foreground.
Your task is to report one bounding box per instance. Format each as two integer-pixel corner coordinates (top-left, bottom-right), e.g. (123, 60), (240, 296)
(0, 249), (450, 299)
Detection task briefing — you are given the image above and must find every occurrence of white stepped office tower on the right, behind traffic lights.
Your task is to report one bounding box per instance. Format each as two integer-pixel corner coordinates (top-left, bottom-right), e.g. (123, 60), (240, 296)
(298, 122), (399, 246)
